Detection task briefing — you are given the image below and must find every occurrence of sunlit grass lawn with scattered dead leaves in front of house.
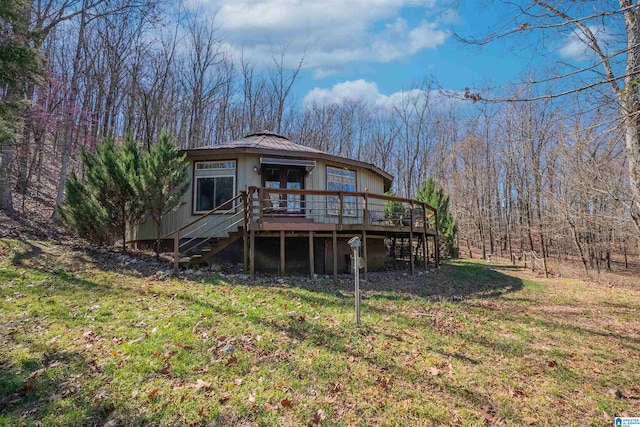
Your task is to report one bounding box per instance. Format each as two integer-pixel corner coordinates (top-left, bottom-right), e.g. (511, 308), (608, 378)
(0, 240), (640, 426)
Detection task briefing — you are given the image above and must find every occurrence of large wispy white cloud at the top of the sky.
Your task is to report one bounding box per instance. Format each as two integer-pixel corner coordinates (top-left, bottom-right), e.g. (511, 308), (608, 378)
(188, 0), (450, 77)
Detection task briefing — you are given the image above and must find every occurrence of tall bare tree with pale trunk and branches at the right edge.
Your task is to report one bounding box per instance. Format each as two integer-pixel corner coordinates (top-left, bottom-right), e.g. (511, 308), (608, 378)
(461, 0), (640, 237)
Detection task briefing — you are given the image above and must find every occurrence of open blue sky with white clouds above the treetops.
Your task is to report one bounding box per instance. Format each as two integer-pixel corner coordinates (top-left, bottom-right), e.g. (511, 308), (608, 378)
(187, 0), (600, 108)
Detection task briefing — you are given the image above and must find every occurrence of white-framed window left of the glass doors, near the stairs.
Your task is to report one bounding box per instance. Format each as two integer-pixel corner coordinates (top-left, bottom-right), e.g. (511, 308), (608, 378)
(193, 160), (236, 213)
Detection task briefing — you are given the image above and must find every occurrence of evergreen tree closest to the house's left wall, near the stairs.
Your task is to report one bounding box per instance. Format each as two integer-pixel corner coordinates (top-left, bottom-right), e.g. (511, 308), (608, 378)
(140, 129), (189, 255)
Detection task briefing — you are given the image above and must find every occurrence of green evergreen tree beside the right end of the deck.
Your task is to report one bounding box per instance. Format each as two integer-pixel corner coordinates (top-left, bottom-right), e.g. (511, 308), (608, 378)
(416, 177), (458, 257)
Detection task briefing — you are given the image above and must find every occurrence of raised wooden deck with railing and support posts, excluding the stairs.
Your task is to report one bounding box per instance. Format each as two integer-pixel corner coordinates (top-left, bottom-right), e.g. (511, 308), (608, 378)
(245, 187), (439, 280)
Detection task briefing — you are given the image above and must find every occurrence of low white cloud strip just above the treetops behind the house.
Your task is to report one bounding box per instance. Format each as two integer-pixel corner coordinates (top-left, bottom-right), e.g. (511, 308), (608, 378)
(302, 79), (462, 110)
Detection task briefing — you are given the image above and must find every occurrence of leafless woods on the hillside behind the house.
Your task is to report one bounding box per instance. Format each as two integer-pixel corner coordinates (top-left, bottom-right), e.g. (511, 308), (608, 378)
(0, 0), (640, 269)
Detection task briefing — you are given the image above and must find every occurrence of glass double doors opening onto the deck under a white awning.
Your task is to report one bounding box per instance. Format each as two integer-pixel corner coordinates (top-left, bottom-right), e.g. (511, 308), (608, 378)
(262, 165), (305, 214)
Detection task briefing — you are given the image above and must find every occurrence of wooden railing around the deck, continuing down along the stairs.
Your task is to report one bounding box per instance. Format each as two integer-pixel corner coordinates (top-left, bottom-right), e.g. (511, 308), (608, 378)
(164, 187), (438, 269)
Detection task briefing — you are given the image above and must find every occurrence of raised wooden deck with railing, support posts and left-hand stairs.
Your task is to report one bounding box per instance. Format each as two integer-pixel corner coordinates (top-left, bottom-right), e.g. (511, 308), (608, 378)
(166, 187), (439, 279)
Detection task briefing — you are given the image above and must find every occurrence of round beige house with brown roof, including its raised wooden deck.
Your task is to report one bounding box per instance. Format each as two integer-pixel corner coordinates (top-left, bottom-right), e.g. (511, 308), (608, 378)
(133, 131), (438, 277)
